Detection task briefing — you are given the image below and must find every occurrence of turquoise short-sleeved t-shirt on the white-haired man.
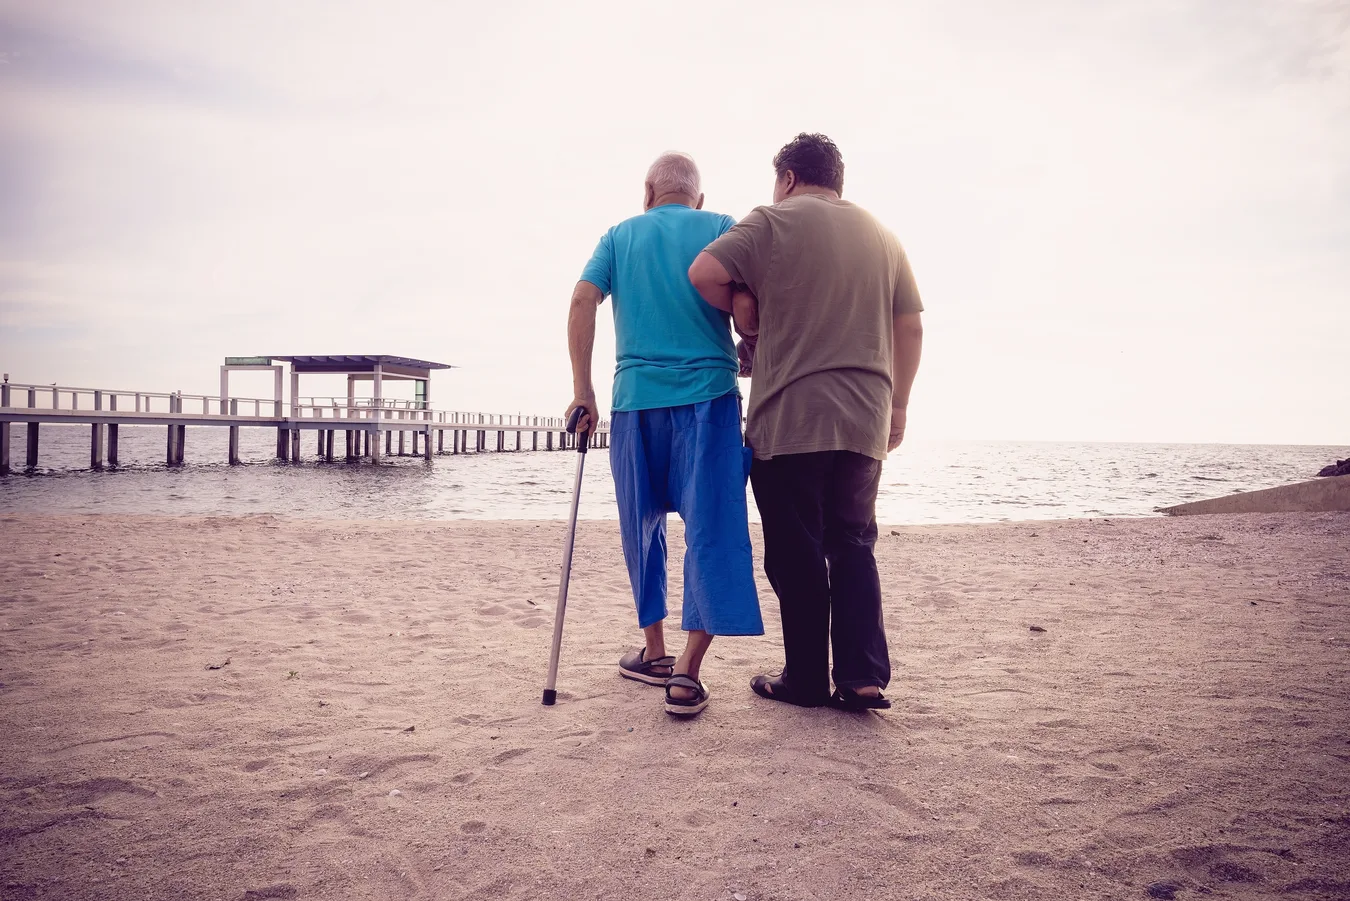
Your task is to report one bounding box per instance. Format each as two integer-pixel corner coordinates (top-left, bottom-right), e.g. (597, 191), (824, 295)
(582, 204), (740, 412)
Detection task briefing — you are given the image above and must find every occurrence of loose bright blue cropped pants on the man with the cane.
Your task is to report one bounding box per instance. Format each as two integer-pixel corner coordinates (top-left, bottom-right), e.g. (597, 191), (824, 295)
(609, 394), (764, 635)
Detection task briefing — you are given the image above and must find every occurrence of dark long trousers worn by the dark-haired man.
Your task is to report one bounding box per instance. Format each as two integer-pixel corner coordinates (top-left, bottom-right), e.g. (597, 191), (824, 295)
(751, 451), (891, 700)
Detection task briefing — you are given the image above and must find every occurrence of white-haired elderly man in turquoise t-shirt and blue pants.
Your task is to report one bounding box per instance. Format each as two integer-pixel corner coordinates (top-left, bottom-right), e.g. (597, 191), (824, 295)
(567, 153), (764, 716)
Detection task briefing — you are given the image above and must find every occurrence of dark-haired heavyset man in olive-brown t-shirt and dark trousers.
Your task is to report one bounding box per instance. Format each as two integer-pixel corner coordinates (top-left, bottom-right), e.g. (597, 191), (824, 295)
(689, 134), (923, 709)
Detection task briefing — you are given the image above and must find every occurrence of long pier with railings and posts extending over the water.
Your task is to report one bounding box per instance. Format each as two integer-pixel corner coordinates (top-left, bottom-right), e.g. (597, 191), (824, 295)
(0, 382), (609, 473)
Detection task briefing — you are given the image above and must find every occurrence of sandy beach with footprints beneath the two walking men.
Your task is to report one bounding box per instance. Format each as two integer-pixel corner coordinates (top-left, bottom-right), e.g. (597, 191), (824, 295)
(0, 513), (1350, 901)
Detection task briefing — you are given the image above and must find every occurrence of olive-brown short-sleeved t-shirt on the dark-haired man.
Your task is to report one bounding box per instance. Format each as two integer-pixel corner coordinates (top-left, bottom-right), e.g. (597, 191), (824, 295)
(706, 195), (923, 459)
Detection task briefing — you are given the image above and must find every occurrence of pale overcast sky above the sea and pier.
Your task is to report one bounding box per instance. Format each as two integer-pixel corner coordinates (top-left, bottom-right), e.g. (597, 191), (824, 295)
(0, 0), (1350, 443)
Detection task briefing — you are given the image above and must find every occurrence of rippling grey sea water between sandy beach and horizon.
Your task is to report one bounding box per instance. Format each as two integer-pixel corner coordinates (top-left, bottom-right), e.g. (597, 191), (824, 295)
(0, 426), (1346, 524)
